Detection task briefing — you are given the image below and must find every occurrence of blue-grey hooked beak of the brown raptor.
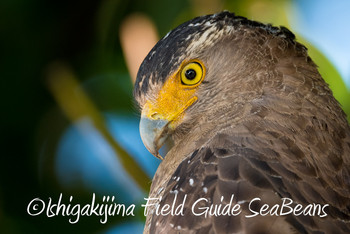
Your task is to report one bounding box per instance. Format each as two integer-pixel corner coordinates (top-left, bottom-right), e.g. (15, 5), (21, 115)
(140, 115), (170, 160)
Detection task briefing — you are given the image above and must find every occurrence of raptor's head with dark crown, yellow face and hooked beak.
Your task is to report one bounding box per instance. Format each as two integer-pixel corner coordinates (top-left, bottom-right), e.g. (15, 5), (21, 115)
(134, 12), (298, 158)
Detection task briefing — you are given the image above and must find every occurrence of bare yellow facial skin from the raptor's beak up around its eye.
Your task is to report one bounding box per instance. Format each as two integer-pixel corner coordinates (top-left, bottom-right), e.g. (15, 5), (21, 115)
(142, 60), (205, 127)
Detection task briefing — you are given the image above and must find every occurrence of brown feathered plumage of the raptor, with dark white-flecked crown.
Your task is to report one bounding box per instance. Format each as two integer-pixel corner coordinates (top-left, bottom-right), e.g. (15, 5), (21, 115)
(134, 12), (350, 233)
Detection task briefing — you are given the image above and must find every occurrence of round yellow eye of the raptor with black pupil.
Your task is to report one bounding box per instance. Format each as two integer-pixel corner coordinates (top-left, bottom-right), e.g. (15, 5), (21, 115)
(181, 62), (203, 85)
